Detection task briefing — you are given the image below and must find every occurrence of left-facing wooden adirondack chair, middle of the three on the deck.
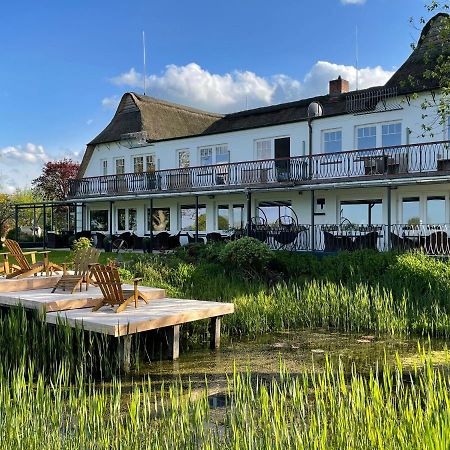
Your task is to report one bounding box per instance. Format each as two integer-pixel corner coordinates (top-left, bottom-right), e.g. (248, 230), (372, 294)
(52, 247), (100, 294)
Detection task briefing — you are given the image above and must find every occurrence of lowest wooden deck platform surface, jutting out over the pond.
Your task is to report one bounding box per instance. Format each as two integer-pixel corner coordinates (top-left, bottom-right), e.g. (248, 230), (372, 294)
(47, 298), (234, 337)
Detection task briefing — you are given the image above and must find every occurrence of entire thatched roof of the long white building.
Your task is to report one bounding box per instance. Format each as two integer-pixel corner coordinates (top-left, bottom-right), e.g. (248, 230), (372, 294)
(78, 13), (450, 177)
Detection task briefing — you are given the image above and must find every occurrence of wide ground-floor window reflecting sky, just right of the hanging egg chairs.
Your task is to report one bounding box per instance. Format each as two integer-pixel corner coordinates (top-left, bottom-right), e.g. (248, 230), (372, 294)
(340, 199), (383, 226)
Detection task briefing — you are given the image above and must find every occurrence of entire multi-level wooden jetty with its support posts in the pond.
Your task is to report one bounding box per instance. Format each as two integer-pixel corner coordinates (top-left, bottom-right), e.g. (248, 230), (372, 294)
(0, 282), (234, 371)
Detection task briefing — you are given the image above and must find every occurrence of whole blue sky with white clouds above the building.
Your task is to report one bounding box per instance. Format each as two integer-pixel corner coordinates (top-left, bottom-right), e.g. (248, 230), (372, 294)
(0, 0), (436, 192)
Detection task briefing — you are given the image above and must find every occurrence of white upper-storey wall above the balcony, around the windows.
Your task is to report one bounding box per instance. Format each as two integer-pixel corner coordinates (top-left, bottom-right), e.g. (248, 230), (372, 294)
(85, 91), (447, 177)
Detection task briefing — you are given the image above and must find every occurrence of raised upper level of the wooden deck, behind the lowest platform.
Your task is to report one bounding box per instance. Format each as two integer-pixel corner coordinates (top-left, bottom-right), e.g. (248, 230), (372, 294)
(0, 286), (166, 312)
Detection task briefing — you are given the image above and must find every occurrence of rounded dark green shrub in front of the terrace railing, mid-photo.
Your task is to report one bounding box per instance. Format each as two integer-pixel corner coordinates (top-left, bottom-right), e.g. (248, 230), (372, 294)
(219, 237), (273, 278)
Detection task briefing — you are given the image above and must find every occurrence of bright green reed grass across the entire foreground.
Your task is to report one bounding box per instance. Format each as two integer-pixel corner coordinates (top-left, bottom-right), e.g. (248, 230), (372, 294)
(0, 353), (450, 450)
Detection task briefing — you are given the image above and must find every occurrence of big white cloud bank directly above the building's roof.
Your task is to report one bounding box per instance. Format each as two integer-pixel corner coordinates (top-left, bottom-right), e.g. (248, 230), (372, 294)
(109, 61), (392, 112)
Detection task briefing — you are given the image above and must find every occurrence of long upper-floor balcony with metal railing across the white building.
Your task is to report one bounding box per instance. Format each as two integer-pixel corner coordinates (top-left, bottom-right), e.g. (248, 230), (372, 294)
(68, 141), (450, 199)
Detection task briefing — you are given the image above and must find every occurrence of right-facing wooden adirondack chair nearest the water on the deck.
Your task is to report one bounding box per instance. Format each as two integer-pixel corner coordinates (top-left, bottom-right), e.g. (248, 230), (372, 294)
(91, 264), (148, 313)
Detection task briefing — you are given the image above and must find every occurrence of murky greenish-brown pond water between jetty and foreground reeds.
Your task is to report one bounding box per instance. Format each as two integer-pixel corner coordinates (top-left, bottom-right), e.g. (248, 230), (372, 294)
(127, 329), (450, 393)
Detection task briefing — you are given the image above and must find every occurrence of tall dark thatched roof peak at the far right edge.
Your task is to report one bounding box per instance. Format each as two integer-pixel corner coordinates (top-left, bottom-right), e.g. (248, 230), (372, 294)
(386, 13), (450, 94)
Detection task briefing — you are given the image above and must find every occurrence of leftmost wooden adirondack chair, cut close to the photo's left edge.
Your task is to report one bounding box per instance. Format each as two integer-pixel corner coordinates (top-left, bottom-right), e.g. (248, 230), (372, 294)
(5, 239), (63, 278)
